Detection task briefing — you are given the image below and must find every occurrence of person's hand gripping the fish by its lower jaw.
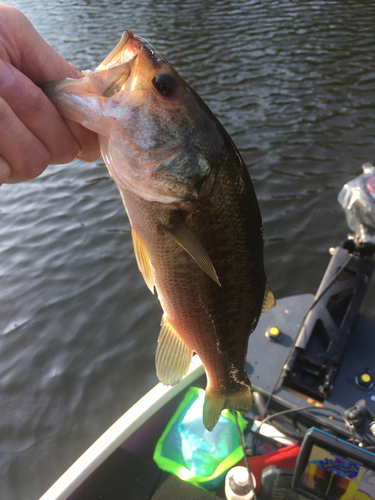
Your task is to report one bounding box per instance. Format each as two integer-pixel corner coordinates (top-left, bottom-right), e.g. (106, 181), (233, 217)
(0, 3), (100, 185)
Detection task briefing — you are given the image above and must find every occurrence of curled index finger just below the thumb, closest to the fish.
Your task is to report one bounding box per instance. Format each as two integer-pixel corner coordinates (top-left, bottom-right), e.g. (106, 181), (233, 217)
(0, 60), (81, 163)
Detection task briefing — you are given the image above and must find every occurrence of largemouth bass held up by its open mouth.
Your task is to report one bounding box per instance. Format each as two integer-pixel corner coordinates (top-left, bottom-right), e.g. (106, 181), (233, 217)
(43, 31), (276, 430)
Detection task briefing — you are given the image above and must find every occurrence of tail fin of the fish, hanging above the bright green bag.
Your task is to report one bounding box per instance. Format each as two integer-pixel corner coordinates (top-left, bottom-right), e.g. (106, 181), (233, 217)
(203, 384), (253, 431)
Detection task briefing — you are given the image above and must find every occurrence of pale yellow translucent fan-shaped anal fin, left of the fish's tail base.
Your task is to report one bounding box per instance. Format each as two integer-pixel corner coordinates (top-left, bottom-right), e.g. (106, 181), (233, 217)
(155, 314), (193, 385)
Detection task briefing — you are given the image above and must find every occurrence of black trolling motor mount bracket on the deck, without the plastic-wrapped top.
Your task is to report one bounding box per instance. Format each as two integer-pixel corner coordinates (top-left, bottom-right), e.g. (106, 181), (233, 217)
(283, 239), (375, 402)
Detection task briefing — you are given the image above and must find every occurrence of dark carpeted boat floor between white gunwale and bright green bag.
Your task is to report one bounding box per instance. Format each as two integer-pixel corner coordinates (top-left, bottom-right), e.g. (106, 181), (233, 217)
(68, 448), (219, 500)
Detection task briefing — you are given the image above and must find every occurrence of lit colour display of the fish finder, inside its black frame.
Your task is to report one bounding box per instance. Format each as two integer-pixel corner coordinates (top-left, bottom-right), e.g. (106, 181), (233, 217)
(300, 444), (375, 500)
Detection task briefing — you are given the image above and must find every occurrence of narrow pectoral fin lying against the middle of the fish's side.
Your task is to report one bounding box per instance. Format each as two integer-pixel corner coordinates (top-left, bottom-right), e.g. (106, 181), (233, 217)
(162, 219), (221, 286)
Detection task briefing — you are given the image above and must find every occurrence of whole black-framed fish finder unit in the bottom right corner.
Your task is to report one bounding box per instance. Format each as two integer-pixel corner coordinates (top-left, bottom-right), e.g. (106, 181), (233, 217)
(292, 428), (375, 500)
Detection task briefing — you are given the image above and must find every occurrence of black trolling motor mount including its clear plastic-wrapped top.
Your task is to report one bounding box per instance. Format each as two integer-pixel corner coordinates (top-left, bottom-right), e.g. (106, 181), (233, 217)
(283, 163), (375, 403)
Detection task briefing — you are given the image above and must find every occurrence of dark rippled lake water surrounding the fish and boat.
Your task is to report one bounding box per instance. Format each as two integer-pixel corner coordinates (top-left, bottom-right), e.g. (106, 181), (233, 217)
(0, 0), (375, 500)
